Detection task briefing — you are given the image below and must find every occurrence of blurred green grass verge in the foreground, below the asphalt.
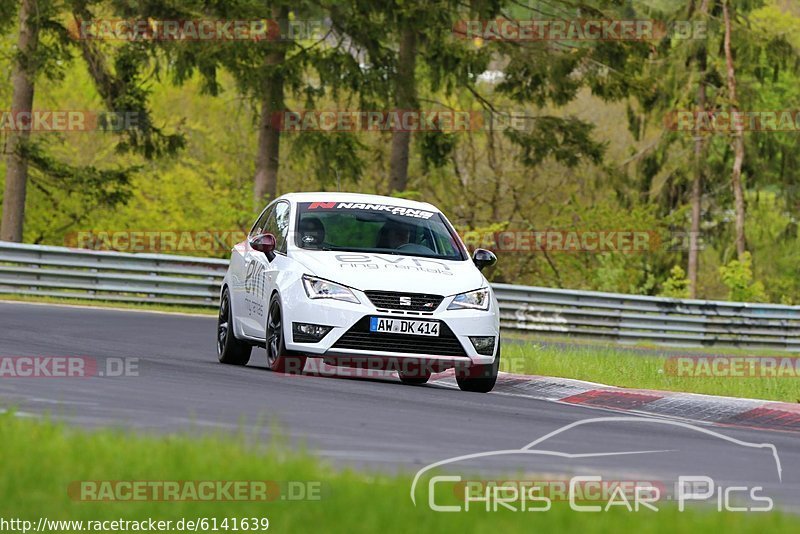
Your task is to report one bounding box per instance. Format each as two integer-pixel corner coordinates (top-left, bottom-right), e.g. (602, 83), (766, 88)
(0, 414), (800, 533)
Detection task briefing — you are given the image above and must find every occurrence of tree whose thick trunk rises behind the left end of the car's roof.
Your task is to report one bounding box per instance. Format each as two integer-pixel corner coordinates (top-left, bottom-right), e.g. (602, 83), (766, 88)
(141, 0), (364, 210)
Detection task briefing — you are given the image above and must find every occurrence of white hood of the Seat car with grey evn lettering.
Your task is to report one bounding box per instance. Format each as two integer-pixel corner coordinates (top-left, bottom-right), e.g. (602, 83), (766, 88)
(290, 249), (487, 296)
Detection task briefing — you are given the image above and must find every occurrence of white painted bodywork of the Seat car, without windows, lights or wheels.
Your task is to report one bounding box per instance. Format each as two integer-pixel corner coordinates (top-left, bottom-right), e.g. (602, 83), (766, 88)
(223, 193), (500, 364)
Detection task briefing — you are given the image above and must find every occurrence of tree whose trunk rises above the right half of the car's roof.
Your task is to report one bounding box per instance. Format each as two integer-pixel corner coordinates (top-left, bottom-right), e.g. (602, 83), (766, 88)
(330, 0), (500, 193)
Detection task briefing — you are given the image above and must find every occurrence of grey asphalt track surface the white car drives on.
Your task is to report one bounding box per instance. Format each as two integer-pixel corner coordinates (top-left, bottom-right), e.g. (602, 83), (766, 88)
(0, 302), (800, 511)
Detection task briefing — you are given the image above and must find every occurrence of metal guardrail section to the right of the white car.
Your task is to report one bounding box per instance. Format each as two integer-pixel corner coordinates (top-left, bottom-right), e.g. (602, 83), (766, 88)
(493, 284), (800, 351)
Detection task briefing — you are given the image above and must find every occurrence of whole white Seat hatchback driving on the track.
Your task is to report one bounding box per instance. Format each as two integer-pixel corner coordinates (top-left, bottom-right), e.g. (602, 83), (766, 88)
(217, 193), (500, 392)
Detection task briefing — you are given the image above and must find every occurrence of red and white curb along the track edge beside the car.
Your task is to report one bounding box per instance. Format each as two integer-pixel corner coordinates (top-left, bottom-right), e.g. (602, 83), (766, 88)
(430, 370), (800, 432)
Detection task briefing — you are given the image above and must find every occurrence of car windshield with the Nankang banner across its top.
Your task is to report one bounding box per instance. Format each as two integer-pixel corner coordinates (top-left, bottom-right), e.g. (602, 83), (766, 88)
(295, 202), (466, 260)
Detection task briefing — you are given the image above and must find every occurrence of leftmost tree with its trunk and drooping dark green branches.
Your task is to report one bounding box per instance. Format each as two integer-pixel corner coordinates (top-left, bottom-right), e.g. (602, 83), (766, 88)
(0, 0), (184, 241)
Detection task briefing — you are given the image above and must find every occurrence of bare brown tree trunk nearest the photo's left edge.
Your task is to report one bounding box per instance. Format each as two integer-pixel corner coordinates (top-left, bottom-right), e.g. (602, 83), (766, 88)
(0, 0), (39, 243)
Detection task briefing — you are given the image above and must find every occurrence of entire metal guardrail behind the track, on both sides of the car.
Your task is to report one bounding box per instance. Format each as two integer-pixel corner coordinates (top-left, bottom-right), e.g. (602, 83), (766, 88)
(0, 241), (800, 351)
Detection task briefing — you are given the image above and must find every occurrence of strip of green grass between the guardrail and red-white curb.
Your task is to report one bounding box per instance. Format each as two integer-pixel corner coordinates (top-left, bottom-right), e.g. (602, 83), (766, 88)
(501, 342), (800, 402)
